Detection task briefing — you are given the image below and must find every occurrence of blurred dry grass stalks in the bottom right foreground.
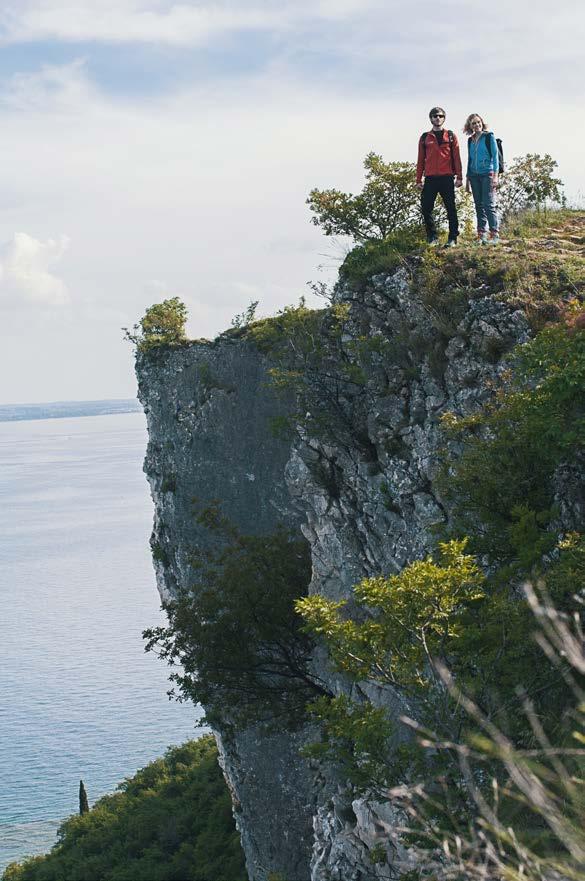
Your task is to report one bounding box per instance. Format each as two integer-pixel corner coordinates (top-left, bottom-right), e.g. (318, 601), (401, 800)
(400, 584), (585, 881)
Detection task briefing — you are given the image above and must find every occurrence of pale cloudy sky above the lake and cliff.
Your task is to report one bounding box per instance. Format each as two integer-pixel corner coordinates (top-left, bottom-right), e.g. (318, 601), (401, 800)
(0, 0), (585, 404)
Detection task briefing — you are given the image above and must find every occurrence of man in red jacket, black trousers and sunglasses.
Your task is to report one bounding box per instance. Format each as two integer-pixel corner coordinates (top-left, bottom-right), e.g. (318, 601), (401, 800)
(416, 107), (463, 248)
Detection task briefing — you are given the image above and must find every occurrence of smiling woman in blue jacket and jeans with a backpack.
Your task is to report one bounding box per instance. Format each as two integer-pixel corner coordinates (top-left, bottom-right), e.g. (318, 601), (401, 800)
(463, 113), (500, 245)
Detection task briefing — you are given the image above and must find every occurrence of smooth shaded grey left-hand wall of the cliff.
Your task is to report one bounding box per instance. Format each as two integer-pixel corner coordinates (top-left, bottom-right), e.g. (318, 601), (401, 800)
(137, 340), (314, 881)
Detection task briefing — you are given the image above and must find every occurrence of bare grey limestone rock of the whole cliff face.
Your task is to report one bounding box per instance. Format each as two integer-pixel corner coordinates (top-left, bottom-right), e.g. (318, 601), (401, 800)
(137, 270), (529, 881)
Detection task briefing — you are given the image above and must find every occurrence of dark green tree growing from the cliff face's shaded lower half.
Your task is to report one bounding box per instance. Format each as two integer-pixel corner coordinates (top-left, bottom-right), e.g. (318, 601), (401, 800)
(144, 508), (325, 726)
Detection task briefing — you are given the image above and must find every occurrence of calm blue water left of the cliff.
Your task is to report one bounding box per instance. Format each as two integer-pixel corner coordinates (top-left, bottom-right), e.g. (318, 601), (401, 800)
(0, 413), (200, 871)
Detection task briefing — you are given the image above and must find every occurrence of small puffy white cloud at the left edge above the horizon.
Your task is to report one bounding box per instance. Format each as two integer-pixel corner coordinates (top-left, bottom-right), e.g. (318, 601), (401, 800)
(0, 232), (69, 309)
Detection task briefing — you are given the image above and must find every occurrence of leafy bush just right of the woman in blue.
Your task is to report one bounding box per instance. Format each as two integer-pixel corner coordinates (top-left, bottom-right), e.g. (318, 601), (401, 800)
(498, 153), (565, 217)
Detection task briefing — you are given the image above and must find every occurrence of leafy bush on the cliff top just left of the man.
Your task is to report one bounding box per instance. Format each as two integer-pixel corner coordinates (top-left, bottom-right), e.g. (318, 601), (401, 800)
(307, 153), (420, 242)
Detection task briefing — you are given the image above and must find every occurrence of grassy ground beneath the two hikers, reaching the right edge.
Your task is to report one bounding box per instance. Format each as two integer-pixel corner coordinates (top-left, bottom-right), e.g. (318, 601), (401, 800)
(414, 210), (585, 330)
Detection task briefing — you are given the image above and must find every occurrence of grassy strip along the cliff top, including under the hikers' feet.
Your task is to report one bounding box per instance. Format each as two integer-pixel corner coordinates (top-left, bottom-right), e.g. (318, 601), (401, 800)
(233, 209), (585, 352)
